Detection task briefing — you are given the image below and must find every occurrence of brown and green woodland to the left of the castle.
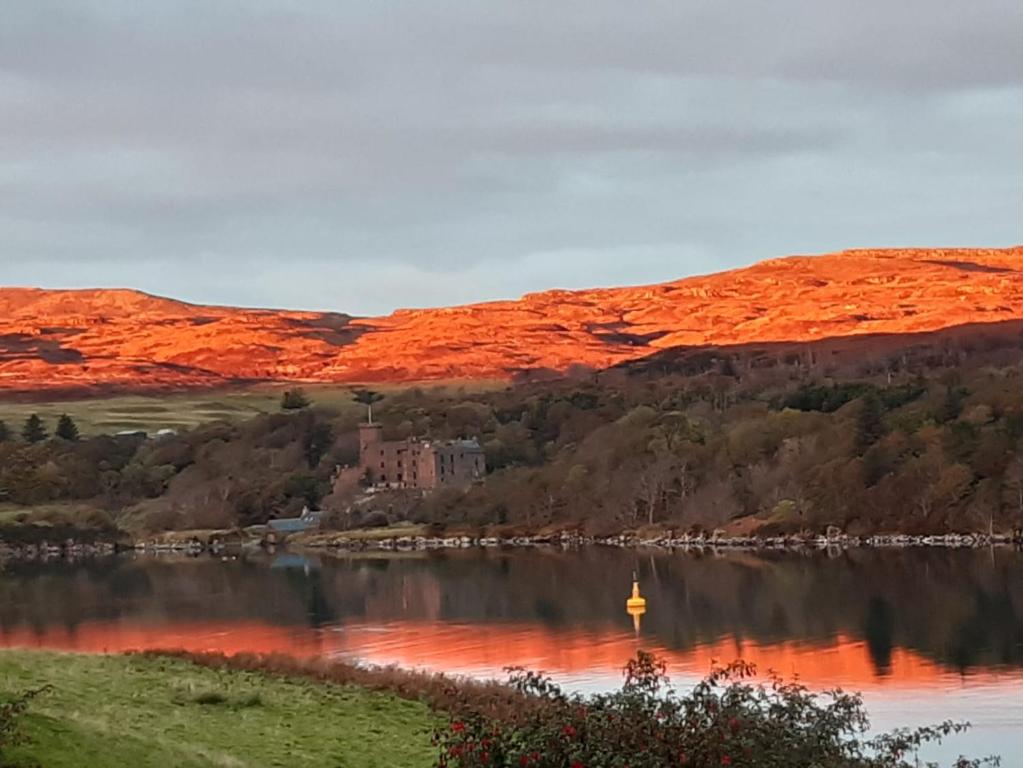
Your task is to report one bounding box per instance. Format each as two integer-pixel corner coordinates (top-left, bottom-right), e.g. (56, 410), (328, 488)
(0, 409), (354, 530)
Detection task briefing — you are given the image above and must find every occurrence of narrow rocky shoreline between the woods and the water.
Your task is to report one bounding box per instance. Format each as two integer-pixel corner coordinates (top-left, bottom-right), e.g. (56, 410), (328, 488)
(0, 532), (1023, 561)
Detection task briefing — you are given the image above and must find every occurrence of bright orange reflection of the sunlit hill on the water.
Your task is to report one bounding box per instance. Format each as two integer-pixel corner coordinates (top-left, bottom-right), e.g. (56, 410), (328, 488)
(0, 620), (998, 690)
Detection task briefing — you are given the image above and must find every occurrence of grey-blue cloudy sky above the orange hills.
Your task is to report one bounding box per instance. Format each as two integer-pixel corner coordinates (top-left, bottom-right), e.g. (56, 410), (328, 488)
(0, 0), (1023, 314)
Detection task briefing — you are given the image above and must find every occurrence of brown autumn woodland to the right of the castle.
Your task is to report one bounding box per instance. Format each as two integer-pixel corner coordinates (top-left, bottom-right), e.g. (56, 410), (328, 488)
(396, 369), (1023, 533)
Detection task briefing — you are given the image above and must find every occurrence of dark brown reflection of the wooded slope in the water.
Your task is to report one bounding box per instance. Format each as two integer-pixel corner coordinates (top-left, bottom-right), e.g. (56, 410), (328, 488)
(0, 549), (1023, 676)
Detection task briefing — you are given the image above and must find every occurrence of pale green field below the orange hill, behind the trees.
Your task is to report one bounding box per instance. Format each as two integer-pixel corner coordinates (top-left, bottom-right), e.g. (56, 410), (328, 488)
(0, 382), (500, 435)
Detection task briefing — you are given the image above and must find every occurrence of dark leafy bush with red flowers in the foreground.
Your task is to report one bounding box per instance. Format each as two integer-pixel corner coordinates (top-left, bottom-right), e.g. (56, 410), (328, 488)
(435, 651), (997, 768)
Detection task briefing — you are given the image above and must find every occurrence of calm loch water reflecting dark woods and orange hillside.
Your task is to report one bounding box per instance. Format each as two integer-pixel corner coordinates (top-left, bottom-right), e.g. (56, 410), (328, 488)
(0, 549), (1023, 766)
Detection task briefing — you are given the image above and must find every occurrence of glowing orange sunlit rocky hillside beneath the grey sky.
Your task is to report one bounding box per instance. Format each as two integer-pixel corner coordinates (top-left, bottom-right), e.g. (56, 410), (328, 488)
(6, 246), (1023, 392)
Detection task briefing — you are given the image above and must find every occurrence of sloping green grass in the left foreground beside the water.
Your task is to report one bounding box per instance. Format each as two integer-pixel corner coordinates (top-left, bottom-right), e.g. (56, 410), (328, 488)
(0, 650), (436, 768)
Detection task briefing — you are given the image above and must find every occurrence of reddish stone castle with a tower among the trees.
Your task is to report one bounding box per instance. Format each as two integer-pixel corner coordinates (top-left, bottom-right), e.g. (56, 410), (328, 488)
(359, 422), (487, 491)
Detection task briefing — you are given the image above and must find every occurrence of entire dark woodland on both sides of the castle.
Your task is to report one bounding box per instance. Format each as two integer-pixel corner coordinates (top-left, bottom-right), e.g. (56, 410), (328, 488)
(0, 321), (1023, 535)
